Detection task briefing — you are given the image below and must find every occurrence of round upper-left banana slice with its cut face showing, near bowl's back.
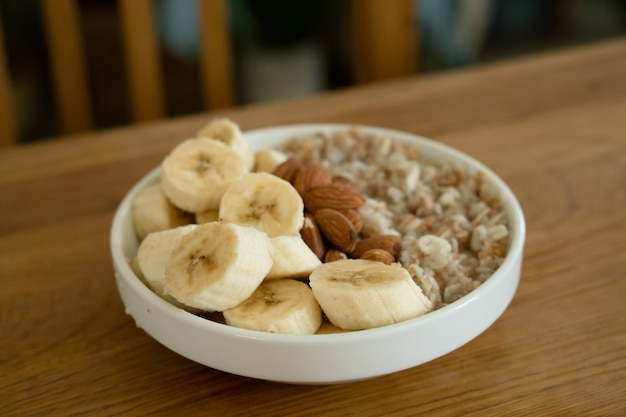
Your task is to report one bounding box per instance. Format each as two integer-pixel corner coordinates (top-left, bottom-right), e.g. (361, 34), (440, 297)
(161, 138), (248, 213)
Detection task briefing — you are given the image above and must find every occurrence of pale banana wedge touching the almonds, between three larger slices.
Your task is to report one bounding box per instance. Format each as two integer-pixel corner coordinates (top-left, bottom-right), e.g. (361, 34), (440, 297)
(265, 236), (322, 279)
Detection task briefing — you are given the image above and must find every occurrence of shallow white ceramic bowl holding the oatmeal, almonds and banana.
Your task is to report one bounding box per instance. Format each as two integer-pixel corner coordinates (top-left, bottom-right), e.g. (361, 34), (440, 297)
(111, 124), (525, 384)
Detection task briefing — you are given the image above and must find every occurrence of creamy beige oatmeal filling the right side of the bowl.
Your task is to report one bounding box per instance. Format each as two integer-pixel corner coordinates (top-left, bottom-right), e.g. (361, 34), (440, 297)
(280, 129), (508, 308)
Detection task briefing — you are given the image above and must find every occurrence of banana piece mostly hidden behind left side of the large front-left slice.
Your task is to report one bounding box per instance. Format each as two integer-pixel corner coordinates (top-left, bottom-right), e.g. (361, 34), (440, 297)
(137, 224), (196, 296)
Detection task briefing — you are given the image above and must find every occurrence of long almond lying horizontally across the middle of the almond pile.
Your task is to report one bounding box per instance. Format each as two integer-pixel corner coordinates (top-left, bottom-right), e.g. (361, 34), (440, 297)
(302, 183), (365, 212)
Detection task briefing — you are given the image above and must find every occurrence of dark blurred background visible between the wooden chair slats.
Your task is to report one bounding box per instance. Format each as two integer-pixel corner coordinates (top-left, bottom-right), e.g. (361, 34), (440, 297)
(0, 0), (626, 142)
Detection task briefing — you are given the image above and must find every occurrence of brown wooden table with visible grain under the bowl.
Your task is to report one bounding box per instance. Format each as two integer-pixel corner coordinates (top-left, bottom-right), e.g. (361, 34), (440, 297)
(0, 39), (626, 416)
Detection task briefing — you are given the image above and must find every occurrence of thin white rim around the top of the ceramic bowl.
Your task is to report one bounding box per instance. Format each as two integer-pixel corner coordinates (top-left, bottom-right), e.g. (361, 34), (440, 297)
(110, 123), (526, 345)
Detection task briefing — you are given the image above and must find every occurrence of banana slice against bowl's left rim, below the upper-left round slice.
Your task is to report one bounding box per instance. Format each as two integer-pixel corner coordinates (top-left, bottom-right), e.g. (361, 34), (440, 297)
(131, 183), (193, 240)
